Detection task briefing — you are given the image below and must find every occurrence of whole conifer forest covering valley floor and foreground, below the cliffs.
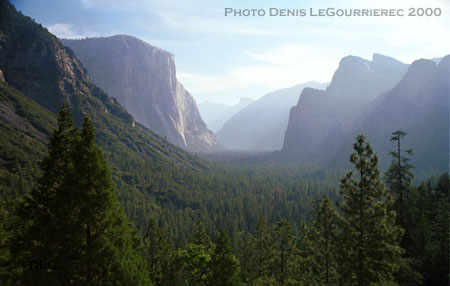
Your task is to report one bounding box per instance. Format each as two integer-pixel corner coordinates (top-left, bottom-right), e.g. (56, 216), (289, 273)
(0, 107), (450, 285)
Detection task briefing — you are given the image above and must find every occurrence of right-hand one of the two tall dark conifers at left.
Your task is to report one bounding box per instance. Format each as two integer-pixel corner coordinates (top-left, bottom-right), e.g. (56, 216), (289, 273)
(65, 117), (149, 285)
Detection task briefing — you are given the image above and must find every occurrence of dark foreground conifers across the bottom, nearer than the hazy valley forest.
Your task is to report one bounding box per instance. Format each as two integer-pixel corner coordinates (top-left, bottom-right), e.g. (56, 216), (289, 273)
(0, 106), (449, 286)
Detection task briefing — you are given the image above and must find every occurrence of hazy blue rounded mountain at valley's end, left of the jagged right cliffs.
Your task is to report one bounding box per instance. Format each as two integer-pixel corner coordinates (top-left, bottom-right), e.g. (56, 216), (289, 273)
(216, 82), (326, 151)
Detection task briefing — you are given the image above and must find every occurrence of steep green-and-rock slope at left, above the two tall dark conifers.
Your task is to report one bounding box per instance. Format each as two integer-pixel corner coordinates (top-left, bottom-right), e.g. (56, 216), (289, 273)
(0, 1), (207, 223)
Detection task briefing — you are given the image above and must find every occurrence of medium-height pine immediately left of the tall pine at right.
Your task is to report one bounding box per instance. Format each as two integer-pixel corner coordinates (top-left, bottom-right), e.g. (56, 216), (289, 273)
(306, 197), (340, 286)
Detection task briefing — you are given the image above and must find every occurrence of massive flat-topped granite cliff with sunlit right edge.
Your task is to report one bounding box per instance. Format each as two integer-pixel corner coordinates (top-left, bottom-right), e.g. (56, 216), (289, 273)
(61, 35), (219, 152)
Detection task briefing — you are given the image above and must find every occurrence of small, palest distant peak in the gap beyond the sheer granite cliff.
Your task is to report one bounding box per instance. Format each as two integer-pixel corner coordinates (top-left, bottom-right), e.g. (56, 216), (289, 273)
(198, 97), (254, 132)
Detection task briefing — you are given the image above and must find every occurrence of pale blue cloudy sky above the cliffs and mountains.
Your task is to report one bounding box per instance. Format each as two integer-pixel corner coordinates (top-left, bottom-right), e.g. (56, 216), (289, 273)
(11, 0), (450, 104)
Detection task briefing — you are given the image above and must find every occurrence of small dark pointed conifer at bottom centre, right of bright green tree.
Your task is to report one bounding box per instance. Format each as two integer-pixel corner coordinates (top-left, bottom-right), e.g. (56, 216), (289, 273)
(208, 230), (239, 286)
